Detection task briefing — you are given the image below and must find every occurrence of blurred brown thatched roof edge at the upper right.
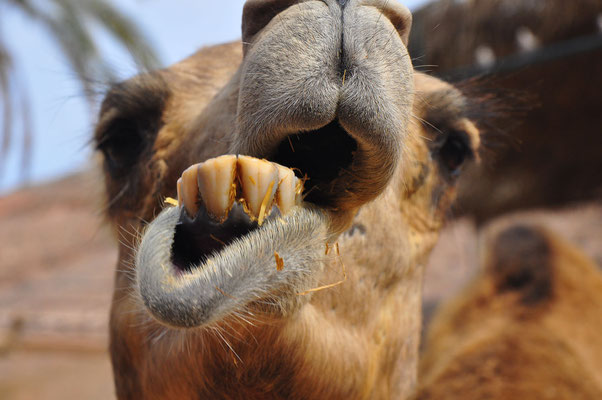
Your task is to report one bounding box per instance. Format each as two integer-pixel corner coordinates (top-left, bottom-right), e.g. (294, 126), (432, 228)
(410, 0), (602, 71)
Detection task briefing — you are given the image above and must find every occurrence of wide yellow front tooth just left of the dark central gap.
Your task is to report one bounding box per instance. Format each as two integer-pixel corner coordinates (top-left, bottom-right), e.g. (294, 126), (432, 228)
(197, 155), (236, 221)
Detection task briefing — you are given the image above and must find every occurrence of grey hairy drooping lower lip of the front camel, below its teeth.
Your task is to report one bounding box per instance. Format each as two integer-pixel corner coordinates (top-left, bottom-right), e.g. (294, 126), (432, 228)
(136, 206), (328, 328)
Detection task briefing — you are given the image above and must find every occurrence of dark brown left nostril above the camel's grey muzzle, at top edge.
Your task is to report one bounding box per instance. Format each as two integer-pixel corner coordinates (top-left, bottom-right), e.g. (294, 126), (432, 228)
(242, 0), (296, 48)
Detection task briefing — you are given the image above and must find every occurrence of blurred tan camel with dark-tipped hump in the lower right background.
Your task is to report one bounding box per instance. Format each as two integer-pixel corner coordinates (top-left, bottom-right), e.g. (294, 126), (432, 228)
(415, 221), (602, 400)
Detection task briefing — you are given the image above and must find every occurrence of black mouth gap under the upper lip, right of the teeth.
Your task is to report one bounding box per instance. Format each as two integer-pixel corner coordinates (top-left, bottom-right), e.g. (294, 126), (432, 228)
(270, 120), (357, 206)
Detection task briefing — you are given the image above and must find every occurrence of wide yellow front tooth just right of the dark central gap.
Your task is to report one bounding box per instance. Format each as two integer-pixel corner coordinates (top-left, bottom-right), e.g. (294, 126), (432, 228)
(238, 156), (278, 225)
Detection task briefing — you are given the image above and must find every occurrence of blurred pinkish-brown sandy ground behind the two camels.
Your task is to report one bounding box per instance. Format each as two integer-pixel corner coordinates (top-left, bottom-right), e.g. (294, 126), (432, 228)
(0, 173), (602, 400)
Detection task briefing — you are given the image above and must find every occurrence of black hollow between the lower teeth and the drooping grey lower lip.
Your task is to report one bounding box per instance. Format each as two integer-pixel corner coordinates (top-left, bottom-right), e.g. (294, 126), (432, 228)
(171, 204), (258, 272)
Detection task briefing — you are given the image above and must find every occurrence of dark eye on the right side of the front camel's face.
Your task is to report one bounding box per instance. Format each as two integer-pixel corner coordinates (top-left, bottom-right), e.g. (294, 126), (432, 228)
(433, 130), (474, 178)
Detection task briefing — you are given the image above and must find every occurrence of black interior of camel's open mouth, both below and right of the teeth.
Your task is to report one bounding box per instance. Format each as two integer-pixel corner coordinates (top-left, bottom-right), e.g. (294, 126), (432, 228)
(171, 120), (357, 273)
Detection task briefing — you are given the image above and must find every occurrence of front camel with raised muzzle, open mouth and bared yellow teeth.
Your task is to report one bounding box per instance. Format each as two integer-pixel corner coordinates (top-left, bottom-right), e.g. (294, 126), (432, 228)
(95, 0), (479, 399)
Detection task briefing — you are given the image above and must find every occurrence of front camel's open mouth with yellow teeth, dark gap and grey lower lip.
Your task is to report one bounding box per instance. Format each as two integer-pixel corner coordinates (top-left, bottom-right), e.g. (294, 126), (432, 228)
(136, 120), (358, 327)
